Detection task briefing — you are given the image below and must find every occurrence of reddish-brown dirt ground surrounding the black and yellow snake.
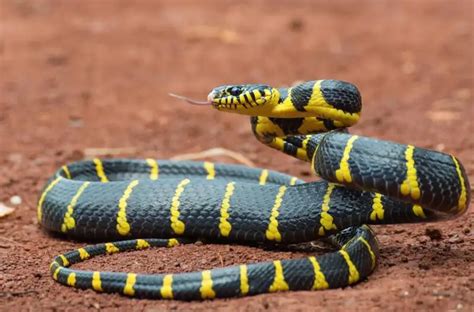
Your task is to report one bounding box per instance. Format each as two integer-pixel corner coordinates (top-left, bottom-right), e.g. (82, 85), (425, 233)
(0, 0), (474, 311)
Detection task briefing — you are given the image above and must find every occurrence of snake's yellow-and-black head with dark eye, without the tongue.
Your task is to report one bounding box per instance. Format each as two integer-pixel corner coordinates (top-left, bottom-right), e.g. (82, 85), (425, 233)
(207, 84), (279, 114)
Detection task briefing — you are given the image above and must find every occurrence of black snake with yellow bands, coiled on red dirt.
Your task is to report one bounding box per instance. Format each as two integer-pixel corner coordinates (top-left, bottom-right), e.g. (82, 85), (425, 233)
(37, 80), (470, 300)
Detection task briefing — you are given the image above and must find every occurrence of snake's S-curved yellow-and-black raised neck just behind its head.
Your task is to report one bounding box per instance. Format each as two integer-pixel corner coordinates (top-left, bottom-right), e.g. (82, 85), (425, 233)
(241, 80), (361, 161)
